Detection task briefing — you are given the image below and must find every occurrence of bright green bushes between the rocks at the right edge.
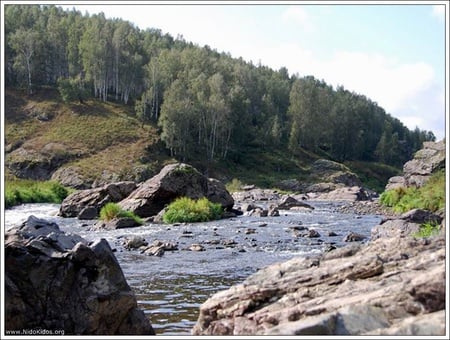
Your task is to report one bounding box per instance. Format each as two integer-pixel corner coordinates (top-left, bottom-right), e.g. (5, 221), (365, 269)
(380, 170), (445, 213)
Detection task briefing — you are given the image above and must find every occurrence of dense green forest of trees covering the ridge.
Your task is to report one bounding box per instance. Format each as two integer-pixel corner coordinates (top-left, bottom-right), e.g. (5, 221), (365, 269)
(4, 5), (435, 166)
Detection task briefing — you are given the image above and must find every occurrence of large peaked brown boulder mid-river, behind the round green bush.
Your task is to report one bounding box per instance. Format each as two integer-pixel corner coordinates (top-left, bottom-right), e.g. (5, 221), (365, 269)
(119, 163), (234, 217)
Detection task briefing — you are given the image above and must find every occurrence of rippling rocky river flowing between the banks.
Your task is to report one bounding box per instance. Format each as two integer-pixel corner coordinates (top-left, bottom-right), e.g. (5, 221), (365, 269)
(4, 202), (380, 335)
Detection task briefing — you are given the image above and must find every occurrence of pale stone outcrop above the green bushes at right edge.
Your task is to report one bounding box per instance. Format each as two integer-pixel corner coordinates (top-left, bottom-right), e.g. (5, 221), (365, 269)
(385, 139), (446, 190)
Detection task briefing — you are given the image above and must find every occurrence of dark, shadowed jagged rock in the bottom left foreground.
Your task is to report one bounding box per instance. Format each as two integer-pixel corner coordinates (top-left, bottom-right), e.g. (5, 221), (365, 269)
(3, 216), (155, 335)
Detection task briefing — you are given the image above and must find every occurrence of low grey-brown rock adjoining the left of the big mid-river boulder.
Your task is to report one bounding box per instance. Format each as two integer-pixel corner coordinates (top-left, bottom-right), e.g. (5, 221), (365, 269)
(59, 182), (136, 219)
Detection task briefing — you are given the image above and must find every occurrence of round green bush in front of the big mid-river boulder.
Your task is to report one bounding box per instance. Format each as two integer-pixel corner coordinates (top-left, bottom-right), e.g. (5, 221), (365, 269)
(163, 197), (223, 223)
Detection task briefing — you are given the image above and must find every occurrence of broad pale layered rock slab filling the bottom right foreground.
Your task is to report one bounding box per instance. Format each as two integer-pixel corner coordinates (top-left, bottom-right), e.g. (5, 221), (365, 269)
(192, 217), (446, 336)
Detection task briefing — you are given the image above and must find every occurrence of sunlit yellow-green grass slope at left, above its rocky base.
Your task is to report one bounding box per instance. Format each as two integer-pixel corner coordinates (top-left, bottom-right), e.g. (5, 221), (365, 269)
(5, 90), (169, 183)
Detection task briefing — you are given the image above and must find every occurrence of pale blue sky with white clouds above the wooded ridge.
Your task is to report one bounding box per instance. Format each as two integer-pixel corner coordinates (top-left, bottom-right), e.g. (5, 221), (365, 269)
(54, 1), (448, 139)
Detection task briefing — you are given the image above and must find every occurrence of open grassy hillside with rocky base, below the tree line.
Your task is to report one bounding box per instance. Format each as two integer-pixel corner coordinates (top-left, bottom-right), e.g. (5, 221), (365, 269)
(5, 88), (398, 190)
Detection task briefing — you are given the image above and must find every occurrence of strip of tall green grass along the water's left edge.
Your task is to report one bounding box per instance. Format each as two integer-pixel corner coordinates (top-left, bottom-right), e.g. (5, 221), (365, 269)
(5, 180), (69, 208)
